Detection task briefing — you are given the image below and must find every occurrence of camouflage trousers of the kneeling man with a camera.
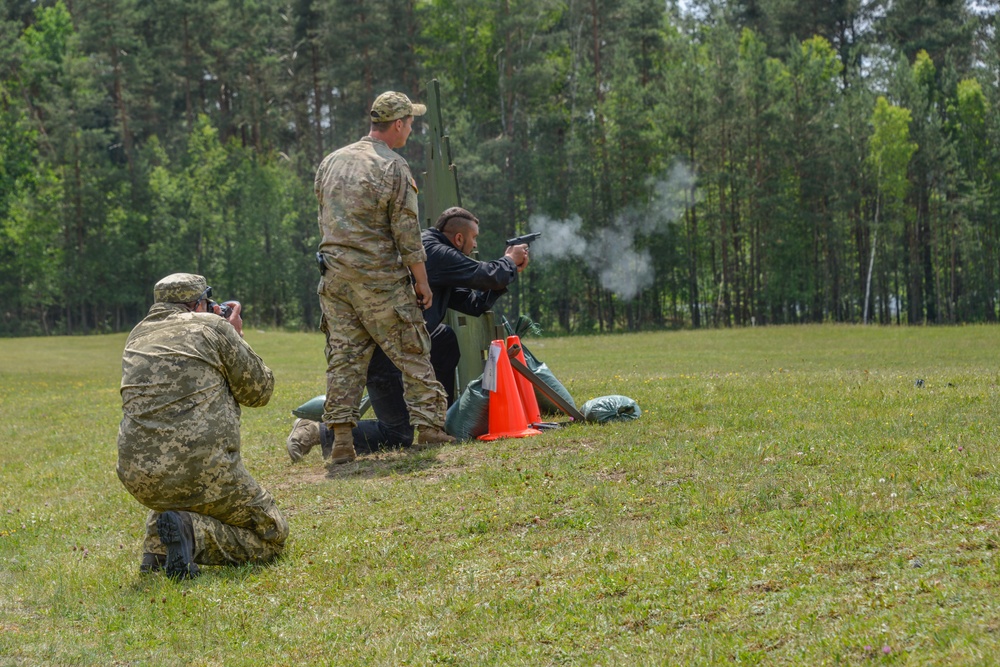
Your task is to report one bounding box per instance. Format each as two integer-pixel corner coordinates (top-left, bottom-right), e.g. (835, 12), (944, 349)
(123, 465), (288, 565)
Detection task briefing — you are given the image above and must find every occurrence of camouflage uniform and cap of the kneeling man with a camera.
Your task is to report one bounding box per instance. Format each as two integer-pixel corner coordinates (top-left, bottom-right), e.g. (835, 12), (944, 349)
(117, 274), (288, 565)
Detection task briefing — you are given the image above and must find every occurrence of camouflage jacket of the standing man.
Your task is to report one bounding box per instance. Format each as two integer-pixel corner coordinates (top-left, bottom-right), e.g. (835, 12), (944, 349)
(315, 137), (427, 283)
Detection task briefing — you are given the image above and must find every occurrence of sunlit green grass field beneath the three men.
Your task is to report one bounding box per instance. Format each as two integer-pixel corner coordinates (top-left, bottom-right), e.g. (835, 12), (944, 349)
(0, 326), (1000, 666)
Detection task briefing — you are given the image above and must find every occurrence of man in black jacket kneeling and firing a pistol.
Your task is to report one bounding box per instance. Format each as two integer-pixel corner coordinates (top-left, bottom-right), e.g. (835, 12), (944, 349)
(287, 206), (528, 462)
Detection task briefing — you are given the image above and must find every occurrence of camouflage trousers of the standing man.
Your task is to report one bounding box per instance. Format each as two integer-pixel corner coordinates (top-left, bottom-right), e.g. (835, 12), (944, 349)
(317, 271), (447, 429)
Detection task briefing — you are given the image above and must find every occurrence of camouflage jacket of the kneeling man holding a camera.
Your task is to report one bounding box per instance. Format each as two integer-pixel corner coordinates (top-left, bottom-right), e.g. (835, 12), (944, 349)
(118, 303), (274, 504)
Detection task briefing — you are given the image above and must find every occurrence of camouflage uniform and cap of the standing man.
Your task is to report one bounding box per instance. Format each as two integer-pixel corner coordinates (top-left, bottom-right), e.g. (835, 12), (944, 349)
(315, 93), (446, 429)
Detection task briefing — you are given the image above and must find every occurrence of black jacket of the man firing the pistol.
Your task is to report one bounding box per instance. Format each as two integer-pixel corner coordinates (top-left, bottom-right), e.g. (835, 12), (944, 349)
(421, 228), (517, 331)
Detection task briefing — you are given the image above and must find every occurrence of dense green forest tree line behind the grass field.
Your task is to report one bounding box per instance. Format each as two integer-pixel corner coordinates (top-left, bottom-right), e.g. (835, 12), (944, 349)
(0, 0), (1000, 335)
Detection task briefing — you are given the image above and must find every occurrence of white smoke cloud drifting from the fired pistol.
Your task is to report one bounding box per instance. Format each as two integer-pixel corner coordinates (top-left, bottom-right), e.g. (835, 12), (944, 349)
(528, 162), (695, 300)
